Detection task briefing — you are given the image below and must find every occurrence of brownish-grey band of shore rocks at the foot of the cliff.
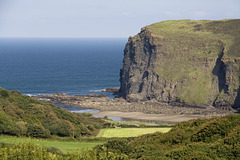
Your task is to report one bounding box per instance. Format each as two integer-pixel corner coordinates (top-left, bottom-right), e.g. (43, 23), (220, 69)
(33, 90), (236, 122)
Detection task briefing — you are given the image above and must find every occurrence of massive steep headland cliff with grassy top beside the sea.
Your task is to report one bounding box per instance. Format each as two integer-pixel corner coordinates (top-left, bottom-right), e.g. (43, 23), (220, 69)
(119, 19), (240, 109)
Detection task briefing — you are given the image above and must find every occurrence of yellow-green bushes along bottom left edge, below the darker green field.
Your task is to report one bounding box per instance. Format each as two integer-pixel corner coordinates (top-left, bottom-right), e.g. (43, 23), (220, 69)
(0, 142), (127, 160)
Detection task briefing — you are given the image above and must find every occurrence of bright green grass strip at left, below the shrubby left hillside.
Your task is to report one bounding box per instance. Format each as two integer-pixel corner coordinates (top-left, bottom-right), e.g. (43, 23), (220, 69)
(0, 136), (104, 154)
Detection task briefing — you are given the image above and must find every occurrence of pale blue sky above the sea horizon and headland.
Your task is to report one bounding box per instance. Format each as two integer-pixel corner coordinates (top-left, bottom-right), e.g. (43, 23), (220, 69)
(0, 0), (240, 37)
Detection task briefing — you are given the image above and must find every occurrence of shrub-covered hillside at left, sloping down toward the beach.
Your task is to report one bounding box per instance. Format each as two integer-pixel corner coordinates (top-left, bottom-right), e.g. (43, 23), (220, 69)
(0, 88), (102, 138)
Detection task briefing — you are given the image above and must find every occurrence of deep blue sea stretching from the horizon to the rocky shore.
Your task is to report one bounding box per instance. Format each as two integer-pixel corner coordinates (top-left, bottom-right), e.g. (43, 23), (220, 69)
(0, 38), (127, 95)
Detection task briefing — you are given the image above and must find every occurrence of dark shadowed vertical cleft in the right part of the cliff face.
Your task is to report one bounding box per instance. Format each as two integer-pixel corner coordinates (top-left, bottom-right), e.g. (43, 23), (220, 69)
(212, 48), (228, 93)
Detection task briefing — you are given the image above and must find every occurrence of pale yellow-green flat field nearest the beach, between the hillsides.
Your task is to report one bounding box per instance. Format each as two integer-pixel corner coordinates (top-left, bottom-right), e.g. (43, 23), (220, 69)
(97, 128), (171, 138)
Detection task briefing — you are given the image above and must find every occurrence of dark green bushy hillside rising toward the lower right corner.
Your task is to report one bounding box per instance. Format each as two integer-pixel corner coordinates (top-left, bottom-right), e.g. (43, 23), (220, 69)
(93, 115), (240, 160)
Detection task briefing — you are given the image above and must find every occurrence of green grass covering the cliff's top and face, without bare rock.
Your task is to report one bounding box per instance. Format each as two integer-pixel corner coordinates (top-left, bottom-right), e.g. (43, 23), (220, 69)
(146, 19), (240, 105)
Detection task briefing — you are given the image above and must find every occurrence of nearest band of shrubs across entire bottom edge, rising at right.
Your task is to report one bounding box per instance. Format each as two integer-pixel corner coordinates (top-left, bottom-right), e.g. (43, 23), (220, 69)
(0, 115), (240, 160)
